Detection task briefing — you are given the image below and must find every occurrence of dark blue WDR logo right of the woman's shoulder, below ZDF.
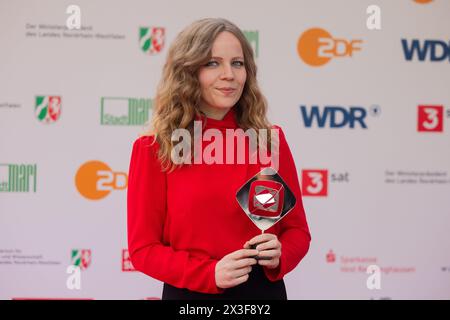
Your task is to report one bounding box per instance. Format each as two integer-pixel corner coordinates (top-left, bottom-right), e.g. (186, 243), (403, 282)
(300, 105), (381, 129)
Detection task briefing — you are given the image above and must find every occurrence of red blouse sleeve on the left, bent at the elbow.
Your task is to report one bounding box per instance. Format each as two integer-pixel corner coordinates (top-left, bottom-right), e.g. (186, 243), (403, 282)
(127, 137), (222, 293)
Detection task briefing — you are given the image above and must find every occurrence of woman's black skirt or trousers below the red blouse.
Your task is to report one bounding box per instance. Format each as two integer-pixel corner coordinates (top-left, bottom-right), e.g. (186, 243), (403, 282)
(162, 265), (287, 300)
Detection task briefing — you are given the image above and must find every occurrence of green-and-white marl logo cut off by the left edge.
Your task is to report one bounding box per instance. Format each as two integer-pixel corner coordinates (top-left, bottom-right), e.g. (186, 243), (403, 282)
(0, 163), (37, 192)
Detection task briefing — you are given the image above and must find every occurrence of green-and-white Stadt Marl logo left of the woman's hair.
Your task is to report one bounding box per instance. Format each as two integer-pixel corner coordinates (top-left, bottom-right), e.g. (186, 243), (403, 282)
(100, 97), (153, 126)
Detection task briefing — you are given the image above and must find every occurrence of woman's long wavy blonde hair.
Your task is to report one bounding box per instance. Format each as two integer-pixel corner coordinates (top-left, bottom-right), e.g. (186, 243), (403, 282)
(143, 18), (272, 171)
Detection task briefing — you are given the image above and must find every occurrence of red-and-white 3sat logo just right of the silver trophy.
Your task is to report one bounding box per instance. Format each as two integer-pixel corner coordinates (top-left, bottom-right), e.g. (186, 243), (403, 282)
(301, 169), (350, 197)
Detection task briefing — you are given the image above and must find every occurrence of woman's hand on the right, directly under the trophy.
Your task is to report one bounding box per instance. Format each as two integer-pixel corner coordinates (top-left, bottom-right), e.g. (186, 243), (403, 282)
(244, 233), (281, 269)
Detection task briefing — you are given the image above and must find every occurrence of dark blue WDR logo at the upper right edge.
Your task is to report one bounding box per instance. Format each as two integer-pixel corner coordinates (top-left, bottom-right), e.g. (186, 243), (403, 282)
(401, 39), (450, 62)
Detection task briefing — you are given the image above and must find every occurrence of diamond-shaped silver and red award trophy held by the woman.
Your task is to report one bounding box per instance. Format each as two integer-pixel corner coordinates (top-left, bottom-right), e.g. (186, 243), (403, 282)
(236, 167), (296, 258)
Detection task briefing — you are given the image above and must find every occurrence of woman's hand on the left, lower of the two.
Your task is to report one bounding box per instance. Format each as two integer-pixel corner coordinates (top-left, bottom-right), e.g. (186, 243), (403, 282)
(216, 249), (258, 289)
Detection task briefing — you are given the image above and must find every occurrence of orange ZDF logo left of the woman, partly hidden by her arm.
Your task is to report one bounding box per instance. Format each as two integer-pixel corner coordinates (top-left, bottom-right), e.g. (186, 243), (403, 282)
(75, 160), (128, 200)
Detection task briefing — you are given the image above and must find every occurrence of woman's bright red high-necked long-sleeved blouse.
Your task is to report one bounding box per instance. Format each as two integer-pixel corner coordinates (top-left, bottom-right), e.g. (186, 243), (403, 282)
(127, 108), (311, 293)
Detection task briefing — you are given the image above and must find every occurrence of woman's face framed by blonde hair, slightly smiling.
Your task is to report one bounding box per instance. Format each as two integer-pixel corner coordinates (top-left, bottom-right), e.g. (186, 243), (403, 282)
(198, 31), (247, 115)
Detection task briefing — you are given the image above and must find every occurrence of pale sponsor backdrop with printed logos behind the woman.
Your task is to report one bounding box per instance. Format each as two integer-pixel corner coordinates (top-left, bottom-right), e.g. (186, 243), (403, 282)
(0, 0), (450, 299)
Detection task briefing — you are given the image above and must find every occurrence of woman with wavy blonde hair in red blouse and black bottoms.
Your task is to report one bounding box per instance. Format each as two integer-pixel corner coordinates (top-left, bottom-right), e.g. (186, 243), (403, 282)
(128, 19), (310, 299)
